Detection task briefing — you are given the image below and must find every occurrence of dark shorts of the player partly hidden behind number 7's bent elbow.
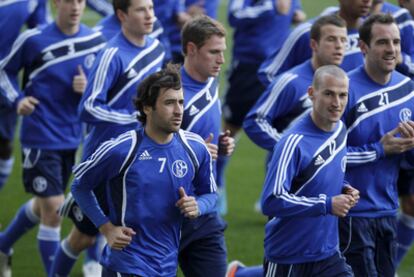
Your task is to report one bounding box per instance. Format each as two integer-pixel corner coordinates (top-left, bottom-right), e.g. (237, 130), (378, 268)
(59, 185), (109, 237)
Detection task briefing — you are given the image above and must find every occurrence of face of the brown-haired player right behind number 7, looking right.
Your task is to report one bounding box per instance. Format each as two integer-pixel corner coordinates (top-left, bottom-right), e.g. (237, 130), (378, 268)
(188, 35), (226, 80)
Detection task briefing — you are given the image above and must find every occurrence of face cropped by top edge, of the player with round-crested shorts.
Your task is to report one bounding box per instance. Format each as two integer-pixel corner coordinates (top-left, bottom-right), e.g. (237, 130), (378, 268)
(55, 0), (85, 31)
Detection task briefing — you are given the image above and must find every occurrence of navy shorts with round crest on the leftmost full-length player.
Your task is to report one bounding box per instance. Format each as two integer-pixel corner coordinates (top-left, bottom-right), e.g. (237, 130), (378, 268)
(22, 148), (76, 197)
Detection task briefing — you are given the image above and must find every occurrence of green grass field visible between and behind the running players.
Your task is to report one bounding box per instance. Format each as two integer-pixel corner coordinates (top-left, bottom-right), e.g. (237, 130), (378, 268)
(0, 0), (414, 277)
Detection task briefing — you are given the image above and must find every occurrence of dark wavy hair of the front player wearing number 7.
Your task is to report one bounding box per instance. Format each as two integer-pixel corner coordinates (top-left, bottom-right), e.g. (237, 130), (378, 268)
(134, 63), (181, 124)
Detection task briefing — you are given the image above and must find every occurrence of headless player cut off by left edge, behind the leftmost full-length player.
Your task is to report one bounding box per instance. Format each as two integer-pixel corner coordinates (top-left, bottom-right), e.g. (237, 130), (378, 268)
(0, 0), (50, 190)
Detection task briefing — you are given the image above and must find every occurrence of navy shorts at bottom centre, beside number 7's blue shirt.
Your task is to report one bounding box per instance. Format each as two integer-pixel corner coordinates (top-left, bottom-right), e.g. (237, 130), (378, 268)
(178, 210), (227, 277)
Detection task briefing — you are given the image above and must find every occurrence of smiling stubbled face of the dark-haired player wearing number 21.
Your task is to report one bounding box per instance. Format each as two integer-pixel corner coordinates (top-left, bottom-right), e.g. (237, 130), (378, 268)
(360, 23), (401, 76)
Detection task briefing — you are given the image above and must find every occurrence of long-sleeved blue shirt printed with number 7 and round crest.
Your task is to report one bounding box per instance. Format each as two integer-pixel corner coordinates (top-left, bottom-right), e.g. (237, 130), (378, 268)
(72, 128), (217, 277)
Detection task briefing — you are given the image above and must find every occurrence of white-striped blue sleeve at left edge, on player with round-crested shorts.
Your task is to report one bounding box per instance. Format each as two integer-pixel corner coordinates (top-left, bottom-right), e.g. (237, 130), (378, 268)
(0, 29), (35, 109)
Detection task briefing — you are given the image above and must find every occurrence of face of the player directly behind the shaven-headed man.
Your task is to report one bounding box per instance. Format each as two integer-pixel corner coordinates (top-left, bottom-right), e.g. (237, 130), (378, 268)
(311, 25), (347, 66)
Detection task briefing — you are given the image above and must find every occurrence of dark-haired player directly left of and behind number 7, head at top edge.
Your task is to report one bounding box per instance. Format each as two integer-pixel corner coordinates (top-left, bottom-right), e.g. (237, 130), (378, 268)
(48, 0), (164, 276)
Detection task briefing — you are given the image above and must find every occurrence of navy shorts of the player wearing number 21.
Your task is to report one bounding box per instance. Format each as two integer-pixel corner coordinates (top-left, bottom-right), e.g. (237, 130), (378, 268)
(339, 216), (397, 277)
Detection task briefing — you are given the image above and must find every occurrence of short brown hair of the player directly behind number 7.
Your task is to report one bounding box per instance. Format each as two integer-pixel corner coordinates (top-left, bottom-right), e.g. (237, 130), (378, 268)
(181, 15), (226, 55)
